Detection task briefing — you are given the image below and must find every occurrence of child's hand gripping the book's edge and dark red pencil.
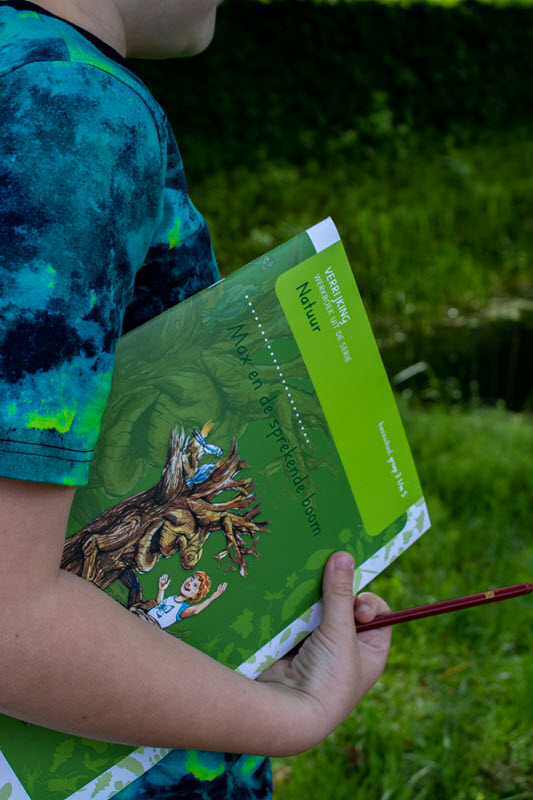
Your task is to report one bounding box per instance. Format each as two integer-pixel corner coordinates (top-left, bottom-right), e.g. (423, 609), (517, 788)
(257, 553), (391, 746)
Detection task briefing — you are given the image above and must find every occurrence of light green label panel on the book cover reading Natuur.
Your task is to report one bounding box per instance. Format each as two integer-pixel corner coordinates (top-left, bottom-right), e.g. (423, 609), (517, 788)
(276, 242), (422, 536)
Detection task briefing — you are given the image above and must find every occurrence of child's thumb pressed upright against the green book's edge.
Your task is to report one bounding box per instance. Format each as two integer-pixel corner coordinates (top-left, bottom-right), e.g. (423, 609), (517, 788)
(320, 552), (355, 635)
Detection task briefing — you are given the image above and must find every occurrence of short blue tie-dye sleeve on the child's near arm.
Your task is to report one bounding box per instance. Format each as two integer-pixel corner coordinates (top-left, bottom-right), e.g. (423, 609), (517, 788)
(0, 62), (166, 485)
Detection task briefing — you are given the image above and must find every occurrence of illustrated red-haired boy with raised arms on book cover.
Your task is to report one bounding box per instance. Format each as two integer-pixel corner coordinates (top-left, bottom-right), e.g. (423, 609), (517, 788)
(130, 570), (228, 628)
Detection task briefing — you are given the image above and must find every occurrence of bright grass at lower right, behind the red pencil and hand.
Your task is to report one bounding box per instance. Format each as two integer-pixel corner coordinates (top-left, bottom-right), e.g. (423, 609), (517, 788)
(274, 408), (533, 800)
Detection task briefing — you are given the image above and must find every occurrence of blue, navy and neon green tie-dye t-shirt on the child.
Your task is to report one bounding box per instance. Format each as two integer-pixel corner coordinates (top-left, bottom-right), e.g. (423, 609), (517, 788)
(0, 0), (271, 800)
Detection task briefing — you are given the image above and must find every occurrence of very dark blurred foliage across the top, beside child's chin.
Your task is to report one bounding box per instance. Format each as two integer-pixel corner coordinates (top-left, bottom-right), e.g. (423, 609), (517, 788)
(135, 0), (533, 177)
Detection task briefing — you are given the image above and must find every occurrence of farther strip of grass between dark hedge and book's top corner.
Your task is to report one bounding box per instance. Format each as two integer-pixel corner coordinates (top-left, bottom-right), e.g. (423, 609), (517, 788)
(193, 138), (533, 316)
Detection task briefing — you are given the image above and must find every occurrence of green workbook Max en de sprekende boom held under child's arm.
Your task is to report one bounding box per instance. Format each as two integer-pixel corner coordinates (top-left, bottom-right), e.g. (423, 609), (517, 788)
(0, 219), (429, 800)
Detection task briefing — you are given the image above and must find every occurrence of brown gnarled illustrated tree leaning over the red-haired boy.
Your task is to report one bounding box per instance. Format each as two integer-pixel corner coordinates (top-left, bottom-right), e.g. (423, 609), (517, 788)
(61, 421), (268, 607)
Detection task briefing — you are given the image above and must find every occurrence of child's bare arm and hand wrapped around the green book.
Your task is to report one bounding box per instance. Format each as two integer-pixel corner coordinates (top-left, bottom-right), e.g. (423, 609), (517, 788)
(0, 479), (390, 755)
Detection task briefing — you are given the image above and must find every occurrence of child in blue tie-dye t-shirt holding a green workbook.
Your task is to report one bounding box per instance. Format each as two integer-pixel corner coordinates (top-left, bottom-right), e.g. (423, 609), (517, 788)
(0, 0), (389, 800)
